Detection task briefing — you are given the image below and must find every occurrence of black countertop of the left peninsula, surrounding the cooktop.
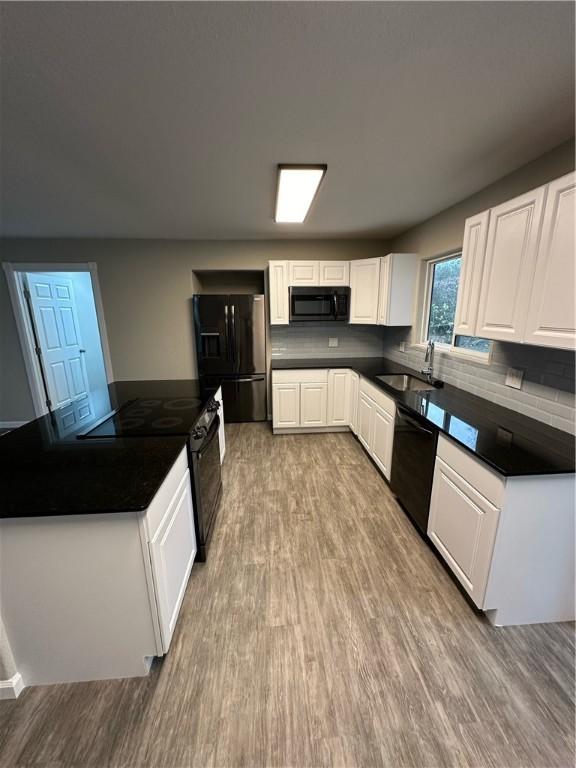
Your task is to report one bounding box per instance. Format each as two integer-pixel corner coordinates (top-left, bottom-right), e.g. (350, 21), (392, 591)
(0, 379), (212, 518)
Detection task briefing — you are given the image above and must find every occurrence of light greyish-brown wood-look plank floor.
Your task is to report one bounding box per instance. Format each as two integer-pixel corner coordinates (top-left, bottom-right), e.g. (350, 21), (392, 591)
(0, 424), (574, 768)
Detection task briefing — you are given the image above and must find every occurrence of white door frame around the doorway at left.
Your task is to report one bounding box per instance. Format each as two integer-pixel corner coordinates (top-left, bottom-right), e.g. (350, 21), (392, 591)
(2, 261), (114, 418)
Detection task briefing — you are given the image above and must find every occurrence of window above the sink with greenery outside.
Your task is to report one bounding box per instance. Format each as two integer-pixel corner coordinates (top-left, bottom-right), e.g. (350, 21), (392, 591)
(422, 253), (490, 354)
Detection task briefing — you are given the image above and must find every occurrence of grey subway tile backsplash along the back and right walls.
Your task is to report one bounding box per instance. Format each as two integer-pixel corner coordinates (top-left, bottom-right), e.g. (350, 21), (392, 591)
(271, 323), (576, 434)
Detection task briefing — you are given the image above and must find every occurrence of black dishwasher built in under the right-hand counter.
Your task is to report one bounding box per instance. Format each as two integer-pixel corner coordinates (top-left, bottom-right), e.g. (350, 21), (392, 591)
(390, 404), (438, 535)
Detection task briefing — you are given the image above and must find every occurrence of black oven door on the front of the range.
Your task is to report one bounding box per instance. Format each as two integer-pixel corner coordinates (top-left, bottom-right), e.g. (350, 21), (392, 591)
(192, 416), (222, 561)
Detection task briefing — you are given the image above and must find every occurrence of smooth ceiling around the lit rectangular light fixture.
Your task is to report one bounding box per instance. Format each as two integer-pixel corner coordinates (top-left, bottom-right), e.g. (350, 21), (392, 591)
(1, 2), (574, 238)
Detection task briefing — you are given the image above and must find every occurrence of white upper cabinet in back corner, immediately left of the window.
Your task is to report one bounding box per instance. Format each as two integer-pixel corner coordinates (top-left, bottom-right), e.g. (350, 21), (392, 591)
(378, 253), (420, 325)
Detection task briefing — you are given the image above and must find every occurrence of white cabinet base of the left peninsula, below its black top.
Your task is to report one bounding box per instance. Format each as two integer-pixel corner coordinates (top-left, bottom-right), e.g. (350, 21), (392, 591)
(0, 448), (196, 686)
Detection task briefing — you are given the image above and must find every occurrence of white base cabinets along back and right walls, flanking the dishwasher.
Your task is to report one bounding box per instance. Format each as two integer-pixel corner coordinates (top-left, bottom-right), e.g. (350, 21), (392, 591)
(272, 369), (576, 626)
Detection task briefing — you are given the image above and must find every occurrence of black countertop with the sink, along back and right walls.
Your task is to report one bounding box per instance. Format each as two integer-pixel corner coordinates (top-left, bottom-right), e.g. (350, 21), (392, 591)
(272, 357), (575, 476)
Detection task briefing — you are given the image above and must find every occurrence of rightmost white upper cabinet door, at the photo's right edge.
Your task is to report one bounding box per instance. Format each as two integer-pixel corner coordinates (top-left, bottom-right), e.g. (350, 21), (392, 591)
(524, 173), (576, 349)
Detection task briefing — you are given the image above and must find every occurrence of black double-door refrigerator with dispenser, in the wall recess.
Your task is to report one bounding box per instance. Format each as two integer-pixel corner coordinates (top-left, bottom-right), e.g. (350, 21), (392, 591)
(192, 294), (267, 421)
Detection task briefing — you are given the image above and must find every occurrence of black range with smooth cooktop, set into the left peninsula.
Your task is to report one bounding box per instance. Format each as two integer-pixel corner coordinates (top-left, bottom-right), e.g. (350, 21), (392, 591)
(78, 397), (222, 562)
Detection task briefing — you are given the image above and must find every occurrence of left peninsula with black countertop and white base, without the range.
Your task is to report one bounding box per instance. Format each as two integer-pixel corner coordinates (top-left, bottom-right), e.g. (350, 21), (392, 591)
(0, 380), (214, 692)
